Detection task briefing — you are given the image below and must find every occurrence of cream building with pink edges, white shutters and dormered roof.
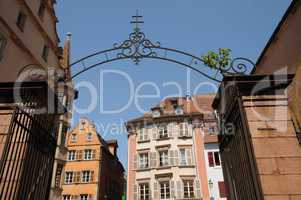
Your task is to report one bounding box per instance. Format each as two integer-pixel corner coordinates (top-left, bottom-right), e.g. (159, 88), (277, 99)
(126, 95), (221, 200)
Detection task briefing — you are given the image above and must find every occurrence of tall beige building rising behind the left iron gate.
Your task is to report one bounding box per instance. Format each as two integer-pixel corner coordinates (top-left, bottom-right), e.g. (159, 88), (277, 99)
(0, 0), (75, 199)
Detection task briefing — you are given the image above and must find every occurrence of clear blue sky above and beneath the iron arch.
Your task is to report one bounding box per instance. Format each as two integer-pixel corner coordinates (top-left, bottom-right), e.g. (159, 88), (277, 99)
(56, 0), (291, 168)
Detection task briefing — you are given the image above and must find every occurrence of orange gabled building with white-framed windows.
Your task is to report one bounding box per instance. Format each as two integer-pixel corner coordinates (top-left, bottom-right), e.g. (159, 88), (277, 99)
(61, 118), (124, 200)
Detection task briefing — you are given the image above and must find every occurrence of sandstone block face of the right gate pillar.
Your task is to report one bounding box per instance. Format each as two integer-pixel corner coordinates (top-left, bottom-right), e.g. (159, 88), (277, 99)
(243, 95), (301, 200)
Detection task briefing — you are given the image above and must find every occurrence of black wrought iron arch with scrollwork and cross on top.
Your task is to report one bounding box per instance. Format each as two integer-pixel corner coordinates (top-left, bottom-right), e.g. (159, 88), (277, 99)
(70, 14), (254, 82)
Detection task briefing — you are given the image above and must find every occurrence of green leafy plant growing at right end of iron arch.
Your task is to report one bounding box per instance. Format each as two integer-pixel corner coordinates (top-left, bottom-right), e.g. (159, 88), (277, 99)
(201, 48), (231, 69)
